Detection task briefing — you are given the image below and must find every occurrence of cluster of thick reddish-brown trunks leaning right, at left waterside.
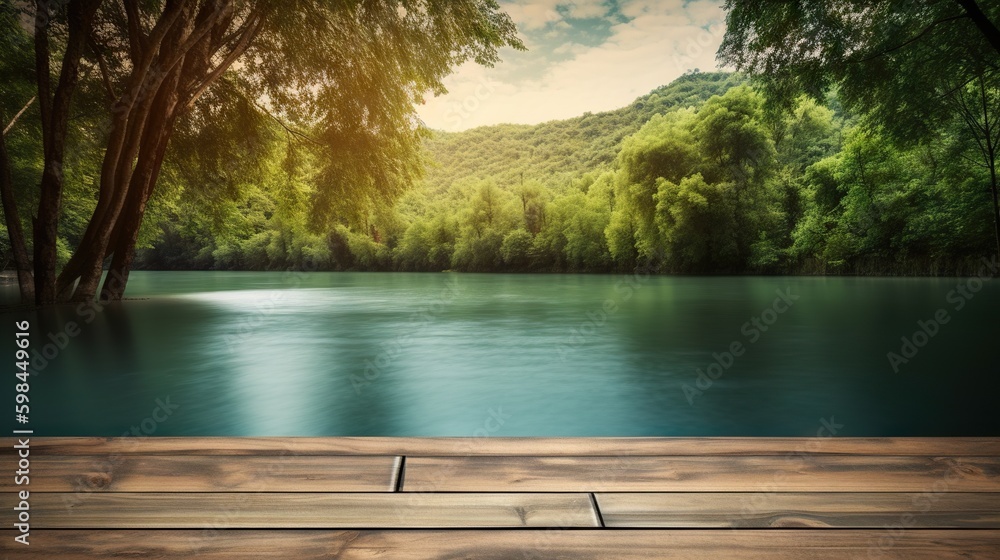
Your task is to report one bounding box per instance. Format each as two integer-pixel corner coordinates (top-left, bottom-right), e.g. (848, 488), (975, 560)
(57, 0), (263, 301)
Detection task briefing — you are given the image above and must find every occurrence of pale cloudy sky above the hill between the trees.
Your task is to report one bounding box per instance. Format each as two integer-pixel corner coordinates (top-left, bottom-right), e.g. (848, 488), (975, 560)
(418, 0), (725, 131)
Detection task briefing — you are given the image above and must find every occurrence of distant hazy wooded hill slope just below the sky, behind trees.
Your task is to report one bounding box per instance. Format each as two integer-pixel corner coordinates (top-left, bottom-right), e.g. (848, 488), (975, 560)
(425, 72), (746, 192)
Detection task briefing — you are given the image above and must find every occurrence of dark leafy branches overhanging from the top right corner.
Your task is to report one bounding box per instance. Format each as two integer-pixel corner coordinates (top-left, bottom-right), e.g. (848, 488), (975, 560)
(718, 0), (1000, 262)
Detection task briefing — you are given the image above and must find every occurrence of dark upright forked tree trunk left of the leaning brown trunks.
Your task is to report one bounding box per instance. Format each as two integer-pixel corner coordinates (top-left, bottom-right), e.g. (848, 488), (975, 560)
(33, 0), (101, 305)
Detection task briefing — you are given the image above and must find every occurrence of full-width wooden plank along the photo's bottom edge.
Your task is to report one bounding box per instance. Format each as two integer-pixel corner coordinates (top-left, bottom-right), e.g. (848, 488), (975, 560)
(7, 529), (1000, 560)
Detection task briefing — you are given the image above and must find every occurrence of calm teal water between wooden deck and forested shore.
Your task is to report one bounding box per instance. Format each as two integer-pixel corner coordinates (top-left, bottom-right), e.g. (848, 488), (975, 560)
(0, 272), (1000, 436)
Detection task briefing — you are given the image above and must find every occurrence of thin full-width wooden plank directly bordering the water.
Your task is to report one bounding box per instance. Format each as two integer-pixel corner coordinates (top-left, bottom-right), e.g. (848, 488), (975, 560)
(7, 437), (1000, 457)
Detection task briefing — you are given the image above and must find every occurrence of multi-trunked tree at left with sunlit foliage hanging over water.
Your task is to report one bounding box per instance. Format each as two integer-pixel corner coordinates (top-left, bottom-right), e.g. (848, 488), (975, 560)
(4, 0), (523, 304)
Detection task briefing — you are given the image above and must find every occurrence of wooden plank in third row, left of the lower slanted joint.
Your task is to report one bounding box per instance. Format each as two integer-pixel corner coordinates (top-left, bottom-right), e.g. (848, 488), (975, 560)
(0, 492), (600, 529)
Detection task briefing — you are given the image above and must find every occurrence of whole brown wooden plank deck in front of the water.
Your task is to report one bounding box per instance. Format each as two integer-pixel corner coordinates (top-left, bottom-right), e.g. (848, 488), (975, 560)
(7, 438), (1000, 560)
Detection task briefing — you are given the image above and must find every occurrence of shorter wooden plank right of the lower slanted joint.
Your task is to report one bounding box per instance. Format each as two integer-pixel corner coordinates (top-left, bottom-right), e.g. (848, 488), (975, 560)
(595, 492), (1000, 529)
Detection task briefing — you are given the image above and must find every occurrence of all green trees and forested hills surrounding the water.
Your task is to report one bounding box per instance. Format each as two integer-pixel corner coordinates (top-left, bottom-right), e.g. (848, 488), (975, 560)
(0, 0), (1000, 301)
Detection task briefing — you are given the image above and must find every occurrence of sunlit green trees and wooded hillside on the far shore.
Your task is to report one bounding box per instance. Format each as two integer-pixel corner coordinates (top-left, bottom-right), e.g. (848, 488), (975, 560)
(133, 73), (992, 274)
